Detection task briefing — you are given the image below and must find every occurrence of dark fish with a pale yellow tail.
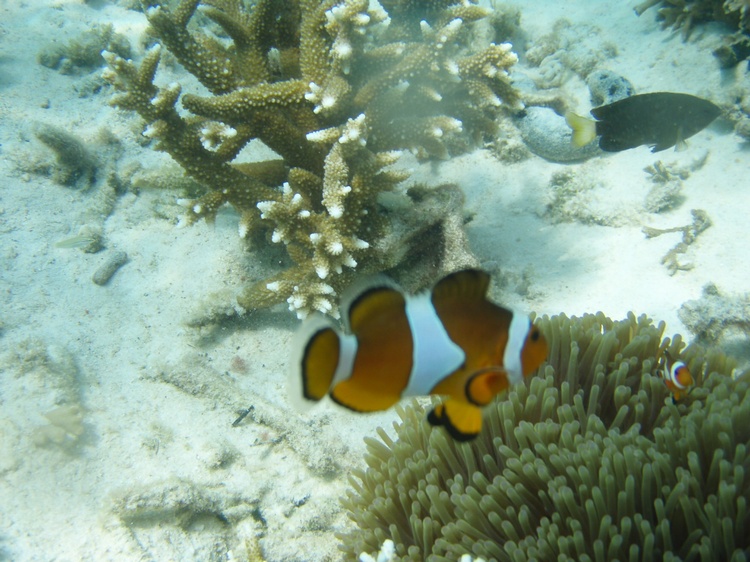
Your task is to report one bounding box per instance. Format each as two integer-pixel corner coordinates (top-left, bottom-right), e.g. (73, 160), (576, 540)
(565, 92), (721, 152)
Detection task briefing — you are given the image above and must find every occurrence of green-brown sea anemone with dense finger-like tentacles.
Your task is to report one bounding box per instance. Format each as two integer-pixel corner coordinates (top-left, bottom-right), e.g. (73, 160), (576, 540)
(339, 313), (750, 562)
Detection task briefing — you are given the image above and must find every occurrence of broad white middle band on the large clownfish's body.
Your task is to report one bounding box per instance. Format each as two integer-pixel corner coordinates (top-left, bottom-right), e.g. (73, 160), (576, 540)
(401, 293), (466, 397)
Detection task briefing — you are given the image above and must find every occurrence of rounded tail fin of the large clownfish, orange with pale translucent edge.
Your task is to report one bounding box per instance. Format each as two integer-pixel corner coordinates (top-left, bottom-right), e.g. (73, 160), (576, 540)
(288, 315), (341, 409)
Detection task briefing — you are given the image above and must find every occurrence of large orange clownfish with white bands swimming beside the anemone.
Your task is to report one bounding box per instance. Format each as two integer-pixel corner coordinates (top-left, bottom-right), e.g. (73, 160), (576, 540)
(290, 269), (547, 441)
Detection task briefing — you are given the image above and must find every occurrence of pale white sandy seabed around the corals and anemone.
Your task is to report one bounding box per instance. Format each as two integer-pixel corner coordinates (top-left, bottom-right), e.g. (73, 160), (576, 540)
(0, 0), (750, 561)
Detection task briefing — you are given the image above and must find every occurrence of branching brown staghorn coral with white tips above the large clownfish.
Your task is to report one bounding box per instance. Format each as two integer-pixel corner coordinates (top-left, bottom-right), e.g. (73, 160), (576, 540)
(105, 0), (518, 316)
